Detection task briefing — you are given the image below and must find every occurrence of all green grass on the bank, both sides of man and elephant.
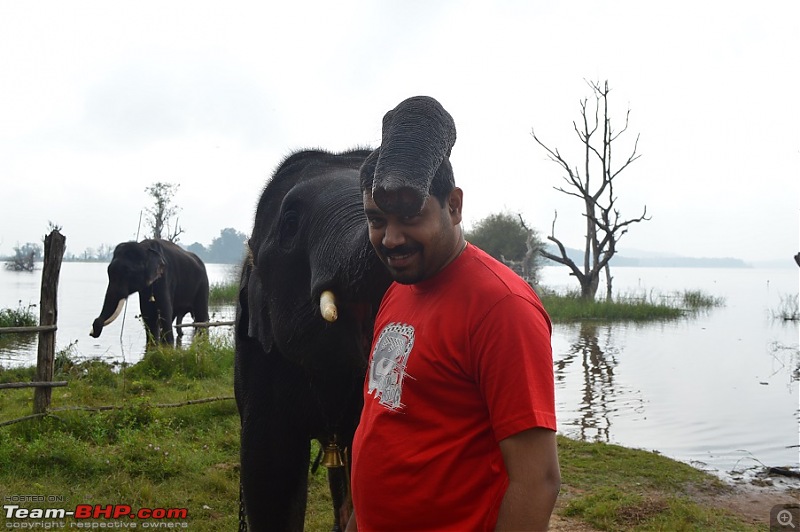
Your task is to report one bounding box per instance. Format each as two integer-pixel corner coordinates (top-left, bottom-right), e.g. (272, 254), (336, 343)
(0, 340), (768, 531)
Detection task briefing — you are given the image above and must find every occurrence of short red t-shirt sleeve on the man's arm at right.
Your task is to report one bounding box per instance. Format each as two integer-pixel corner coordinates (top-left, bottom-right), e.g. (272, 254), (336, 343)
(471, 294), (556, 442)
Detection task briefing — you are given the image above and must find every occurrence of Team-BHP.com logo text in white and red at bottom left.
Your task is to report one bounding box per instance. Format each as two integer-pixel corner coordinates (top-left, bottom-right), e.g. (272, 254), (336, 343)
(3, 504), (189, 529)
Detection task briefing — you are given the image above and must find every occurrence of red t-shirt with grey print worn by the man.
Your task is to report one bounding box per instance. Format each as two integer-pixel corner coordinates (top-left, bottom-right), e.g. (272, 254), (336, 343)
(352, 245), (556, 531)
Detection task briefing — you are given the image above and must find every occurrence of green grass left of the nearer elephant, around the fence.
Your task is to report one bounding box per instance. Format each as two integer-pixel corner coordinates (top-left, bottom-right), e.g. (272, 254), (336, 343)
(0, 342), (239, 530)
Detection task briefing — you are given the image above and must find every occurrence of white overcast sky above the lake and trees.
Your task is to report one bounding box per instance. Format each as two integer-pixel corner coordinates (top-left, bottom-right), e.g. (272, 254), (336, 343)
(0, 0), (800, 261)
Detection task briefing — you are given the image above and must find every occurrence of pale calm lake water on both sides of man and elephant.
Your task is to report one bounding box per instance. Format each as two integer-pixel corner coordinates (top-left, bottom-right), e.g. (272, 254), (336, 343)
(0, 262), (800, 479)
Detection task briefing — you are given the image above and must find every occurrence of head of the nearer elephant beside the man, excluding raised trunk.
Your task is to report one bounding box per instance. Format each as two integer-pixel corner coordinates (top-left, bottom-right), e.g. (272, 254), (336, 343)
(238, 151), (390, 369)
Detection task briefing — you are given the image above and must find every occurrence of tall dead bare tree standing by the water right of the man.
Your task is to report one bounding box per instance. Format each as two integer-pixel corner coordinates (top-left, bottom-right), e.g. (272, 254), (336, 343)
(531, 81), (650, 299)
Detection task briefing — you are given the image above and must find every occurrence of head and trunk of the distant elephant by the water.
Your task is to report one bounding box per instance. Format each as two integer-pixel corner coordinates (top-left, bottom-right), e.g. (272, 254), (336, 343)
(90, 240), (165, 338)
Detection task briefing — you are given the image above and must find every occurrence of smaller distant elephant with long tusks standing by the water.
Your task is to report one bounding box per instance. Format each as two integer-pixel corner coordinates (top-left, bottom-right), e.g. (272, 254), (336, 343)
(90, 239), (208, 344)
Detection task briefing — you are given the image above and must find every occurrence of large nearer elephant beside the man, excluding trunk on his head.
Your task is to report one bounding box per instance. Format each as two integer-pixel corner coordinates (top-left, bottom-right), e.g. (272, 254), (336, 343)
(235, 150), (390, 531)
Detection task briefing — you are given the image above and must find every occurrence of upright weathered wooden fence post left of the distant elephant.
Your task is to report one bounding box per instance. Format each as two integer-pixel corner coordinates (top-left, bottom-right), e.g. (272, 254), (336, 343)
(33, 229), (66, 414)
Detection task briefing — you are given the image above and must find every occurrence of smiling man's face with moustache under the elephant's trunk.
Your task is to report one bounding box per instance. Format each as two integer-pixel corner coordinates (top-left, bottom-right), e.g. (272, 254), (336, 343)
(364, 188), (462, 284)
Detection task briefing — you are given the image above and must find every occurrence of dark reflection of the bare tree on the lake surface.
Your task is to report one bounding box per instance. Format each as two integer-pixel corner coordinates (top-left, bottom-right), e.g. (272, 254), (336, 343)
(553, 322), (644, 442)
